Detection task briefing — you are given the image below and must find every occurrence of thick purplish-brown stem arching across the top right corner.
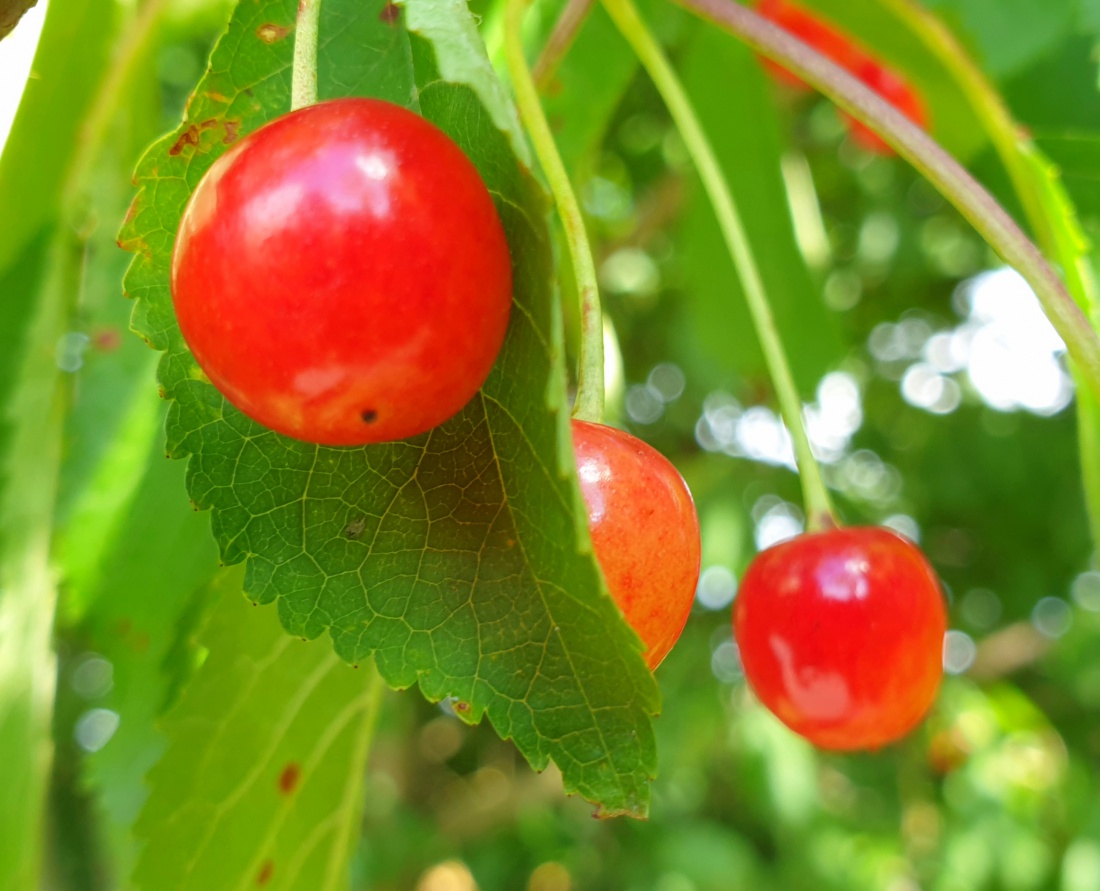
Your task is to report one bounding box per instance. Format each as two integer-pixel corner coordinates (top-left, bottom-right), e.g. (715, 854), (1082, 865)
(675, 0), (1100, 397)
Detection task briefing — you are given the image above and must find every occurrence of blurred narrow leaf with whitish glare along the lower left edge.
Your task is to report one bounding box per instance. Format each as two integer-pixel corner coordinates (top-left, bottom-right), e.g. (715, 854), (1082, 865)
(0, 224), (73, 891)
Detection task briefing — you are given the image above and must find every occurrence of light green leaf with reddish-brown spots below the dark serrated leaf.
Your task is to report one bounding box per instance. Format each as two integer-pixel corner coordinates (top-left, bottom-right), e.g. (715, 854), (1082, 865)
(134, 571), (382, 891)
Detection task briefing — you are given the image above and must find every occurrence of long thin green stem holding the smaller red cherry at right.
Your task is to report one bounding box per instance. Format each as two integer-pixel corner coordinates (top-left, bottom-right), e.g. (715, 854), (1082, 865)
(604, 0), (837, 531)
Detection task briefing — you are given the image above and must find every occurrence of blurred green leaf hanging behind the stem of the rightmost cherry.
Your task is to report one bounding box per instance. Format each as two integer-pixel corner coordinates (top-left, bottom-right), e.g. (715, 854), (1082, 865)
(680, 29), (843, 397)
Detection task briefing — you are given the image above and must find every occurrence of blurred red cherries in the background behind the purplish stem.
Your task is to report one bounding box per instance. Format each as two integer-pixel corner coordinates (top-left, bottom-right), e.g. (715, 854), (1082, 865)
(757, 0), (928, 154)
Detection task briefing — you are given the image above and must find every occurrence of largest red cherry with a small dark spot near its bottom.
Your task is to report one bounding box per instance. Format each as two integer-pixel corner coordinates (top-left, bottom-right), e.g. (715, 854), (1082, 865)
(172, 98), (512, 446)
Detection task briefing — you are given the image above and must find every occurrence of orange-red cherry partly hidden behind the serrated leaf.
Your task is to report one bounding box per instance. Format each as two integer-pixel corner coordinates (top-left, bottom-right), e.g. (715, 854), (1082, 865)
(573, 420), (701, 670)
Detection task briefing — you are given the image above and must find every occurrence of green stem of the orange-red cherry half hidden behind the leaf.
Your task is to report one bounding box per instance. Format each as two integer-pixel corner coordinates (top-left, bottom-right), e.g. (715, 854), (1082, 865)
(504, 0), (604, 424)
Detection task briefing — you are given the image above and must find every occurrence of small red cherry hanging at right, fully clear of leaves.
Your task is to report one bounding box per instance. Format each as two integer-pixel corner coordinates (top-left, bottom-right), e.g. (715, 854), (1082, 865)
(734, 527), (947, 750)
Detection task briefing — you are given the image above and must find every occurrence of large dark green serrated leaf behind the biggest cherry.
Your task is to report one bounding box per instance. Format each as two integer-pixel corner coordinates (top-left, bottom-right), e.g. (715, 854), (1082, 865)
(122, 0), (657, 815)
